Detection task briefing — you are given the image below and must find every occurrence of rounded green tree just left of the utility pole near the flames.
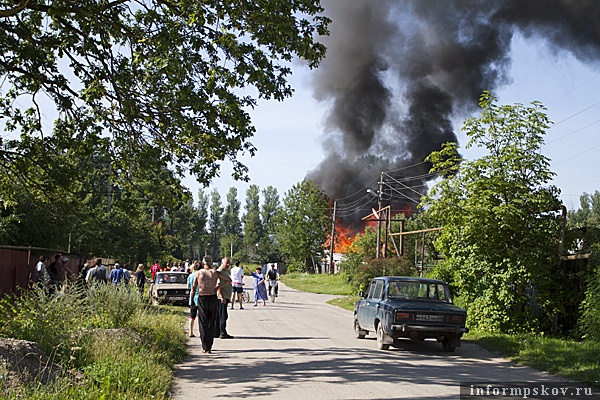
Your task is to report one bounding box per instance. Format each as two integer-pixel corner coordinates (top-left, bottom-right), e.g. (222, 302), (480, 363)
(276, 179), (331, 271)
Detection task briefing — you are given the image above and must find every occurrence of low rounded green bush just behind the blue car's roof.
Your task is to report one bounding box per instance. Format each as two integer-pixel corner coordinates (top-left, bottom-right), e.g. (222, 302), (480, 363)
(350, 257), (418, 291)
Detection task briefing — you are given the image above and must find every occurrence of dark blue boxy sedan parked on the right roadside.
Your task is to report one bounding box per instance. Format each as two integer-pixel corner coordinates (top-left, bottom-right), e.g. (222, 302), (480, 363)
(354, 276), (469, 351)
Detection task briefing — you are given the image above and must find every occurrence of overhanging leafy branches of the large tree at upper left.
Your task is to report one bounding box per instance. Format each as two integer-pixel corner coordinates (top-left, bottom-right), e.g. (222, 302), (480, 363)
(0, 0), (329, 205)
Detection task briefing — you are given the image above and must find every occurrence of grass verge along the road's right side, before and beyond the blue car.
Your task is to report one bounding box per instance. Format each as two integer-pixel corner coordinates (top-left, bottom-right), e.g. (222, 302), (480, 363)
(282, 274), (600, 386)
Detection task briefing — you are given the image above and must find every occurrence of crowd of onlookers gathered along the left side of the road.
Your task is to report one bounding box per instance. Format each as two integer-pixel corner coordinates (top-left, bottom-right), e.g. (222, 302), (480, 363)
(33, 254), (279, 353)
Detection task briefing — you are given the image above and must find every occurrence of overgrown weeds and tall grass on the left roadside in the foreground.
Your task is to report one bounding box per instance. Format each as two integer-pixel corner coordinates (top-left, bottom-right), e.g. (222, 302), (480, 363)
(0, 287), (187, 400)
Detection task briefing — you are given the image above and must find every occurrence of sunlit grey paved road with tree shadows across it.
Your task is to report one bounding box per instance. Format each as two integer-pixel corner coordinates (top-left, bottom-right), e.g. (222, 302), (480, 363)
(173, 280), (557, 400)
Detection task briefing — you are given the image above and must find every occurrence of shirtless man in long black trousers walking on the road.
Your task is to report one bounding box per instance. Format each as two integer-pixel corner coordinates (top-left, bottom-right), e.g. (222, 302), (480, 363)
(192, 256), (231, 354)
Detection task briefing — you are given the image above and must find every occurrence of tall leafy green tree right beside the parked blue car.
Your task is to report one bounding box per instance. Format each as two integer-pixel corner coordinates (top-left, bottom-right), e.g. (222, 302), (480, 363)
(423, 92), (560, 331)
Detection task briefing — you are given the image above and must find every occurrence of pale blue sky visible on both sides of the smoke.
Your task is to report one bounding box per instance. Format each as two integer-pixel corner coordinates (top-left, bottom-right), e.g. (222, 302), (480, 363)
(196, 34), (600, 209)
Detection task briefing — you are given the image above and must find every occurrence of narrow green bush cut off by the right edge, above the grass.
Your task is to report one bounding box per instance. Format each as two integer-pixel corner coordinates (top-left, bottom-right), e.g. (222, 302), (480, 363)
(578, 253), (600, 342)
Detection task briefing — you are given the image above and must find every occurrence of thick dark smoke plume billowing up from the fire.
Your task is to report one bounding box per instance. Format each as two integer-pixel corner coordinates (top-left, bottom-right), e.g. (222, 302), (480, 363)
(307, 0), (600, 222)
